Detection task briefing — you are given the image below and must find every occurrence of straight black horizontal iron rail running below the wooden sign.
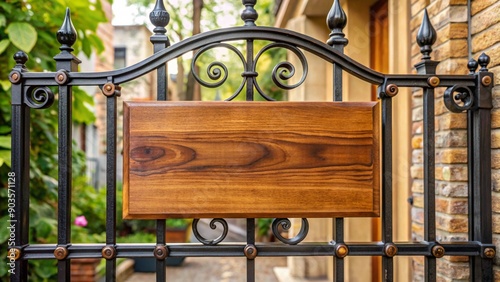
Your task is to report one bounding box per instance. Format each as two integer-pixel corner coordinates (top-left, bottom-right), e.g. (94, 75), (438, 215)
(22, 242), (491, 260)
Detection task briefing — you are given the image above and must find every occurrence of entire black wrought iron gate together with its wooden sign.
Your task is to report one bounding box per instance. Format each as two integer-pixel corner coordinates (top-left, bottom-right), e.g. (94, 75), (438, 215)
(9, 0), (496, 281)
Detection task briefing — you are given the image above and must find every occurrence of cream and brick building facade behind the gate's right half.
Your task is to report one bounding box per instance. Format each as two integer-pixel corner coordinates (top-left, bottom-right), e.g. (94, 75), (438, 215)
(276, 0), (500, 281)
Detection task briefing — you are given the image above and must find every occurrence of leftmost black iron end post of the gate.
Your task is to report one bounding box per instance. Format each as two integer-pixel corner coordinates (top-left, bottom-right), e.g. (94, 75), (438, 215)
(9, 77), (30, 282)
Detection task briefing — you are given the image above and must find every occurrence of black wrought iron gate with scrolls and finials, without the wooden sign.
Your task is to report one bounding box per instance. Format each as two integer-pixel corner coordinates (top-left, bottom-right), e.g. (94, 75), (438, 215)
(9, 0), (495, 281)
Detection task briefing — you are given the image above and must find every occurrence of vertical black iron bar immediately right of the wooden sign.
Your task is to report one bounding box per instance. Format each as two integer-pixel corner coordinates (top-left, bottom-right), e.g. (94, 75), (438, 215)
(381, 97), (394, 281)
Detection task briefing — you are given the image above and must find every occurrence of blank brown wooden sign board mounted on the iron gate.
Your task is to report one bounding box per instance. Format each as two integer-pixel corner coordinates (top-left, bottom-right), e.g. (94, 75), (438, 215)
(123, 102), (380, 219)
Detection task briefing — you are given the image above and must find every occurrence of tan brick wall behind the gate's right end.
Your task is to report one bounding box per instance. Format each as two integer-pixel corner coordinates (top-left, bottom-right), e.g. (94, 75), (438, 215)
(410, 0), (500, 281)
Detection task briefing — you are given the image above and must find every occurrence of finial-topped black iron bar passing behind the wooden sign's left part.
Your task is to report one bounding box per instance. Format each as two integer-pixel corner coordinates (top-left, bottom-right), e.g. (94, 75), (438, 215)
(149, 0), (170, 282)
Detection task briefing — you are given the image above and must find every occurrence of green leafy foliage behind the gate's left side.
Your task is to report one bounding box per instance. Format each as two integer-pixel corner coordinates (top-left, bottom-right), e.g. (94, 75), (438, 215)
(0, 0), (107, 281)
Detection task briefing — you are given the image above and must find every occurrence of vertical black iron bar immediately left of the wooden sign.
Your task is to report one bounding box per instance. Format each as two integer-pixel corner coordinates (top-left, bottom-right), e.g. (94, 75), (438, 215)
(106, 92), (117, 282)
